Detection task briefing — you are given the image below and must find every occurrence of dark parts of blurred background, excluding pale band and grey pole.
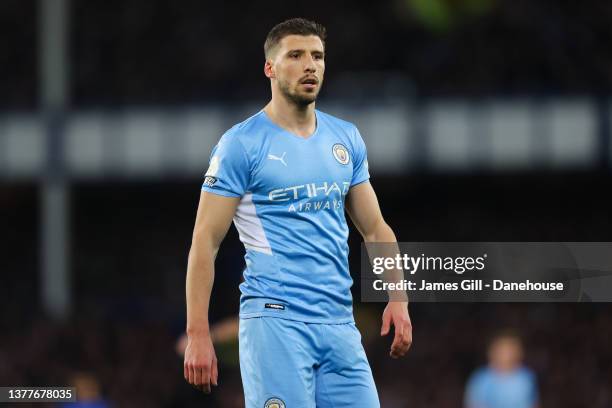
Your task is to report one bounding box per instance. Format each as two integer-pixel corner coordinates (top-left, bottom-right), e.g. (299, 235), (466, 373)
(0, 0), (612, 408)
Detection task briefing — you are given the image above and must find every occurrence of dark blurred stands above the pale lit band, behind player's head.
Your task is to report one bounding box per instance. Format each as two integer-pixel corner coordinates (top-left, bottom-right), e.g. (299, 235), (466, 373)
(0, 0), (612, 109)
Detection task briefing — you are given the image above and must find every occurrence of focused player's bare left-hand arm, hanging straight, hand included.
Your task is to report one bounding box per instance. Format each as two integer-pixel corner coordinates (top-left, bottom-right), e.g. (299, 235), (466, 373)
(184, 192), (240, 393)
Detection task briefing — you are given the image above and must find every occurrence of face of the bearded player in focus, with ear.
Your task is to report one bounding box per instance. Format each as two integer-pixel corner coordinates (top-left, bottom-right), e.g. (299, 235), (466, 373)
(266, 35), (325, 106)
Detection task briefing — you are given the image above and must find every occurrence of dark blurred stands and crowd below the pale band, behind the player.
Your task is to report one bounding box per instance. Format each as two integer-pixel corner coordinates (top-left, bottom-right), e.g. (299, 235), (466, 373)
(0, 173), (612, 408)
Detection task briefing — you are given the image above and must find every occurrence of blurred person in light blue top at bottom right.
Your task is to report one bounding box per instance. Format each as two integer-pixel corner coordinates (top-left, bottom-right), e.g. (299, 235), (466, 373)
(465, 330), (539, 408)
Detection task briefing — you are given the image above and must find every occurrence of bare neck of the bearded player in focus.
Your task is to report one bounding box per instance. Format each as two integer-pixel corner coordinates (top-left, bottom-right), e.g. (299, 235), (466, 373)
(264, 94), (317, 137)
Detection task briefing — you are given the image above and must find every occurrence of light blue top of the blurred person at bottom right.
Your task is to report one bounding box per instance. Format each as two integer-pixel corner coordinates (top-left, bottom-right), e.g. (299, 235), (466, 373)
(465, 367), (538, 408)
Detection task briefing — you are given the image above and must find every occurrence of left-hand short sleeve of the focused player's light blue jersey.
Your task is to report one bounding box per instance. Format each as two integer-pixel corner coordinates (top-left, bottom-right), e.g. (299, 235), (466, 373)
(202, 133), (250, 197)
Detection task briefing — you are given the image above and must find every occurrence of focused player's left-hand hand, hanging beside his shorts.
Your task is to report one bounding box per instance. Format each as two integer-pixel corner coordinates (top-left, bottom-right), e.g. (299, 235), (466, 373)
(183, 334), (219, 394)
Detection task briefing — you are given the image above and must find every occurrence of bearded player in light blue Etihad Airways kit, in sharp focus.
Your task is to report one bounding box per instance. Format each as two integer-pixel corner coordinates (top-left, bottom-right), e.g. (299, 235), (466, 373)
(184, 19), (412, 408)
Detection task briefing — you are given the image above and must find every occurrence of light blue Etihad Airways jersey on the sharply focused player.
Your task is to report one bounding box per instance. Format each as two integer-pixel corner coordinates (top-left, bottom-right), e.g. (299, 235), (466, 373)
(202, 110), (370, 324)
